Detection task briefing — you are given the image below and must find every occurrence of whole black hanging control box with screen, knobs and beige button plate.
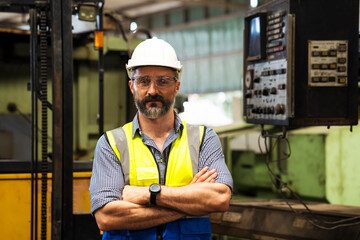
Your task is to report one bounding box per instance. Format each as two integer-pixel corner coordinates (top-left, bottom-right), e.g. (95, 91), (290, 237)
(243, 0), (359, 126)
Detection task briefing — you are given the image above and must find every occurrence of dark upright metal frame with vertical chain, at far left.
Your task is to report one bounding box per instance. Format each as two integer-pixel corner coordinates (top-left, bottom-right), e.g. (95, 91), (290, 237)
(0, 0), (73, 240)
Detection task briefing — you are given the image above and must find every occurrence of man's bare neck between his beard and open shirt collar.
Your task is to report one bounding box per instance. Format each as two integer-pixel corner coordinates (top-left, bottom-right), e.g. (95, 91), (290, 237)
(139, 108), (175, 140)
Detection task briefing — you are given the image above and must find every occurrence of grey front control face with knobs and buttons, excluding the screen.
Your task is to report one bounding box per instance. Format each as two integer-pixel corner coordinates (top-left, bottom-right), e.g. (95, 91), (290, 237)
(244, 6), (293, 125)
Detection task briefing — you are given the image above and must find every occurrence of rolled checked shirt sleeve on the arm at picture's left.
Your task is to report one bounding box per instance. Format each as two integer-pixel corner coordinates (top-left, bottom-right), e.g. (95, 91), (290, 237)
(89, 135), (124, 214)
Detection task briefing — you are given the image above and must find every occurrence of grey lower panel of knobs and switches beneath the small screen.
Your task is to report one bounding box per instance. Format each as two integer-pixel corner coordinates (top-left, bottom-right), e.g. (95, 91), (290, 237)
(245, 59), (289, 120)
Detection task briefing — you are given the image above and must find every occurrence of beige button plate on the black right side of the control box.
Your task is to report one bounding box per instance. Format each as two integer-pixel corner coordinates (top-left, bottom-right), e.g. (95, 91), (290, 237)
(308, 40), (348, 87)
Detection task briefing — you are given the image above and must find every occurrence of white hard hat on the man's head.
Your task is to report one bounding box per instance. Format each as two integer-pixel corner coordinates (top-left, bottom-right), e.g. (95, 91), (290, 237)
(126, 37), (182, 79)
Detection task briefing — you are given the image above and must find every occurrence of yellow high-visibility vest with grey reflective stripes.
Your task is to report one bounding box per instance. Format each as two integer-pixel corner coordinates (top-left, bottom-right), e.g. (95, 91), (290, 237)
(106, 121), (204, 187)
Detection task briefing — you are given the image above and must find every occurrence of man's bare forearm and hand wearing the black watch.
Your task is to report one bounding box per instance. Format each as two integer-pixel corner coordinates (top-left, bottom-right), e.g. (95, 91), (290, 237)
(123, 168), (231, 215)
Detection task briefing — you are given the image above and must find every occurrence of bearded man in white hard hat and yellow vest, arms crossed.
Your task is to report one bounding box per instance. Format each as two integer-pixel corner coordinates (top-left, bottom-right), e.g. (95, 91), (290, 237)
(90, 38), (233, 240)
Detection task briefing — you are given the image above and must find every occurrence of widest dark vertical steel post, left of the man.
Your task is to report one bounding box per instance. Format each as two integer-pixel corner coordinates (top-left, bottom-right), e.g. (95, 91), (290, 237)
(50, 0), (73, 240)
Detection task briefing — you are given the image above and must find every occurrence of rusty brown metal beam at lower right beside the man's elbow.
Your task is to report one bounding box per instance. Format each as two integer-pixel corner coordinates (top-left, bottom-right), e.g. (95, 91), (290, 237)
(210, 200), (360, 240)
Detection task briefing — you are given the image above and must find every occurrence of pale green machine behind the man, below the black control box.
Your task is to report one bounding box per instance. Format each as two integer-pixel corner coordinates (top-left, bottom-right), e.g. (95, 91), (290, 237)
(226, 126), (360, 206)
